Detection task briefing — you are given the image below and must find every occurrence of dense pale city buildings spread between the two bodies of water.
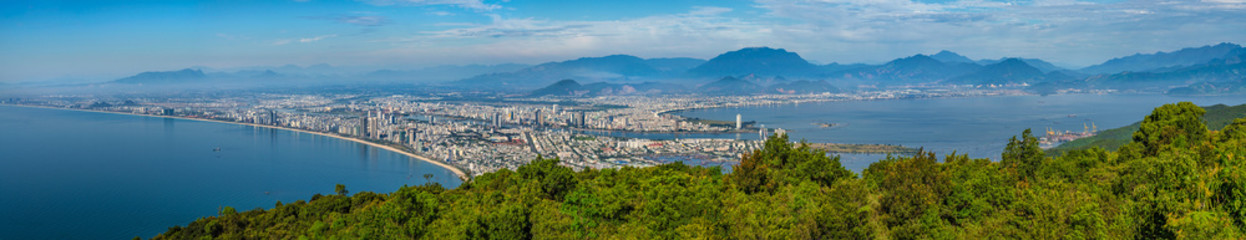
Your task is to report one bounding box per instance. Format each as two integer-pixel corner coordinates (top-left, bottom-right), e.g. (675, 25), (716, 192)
(4, 90), (1024, 178)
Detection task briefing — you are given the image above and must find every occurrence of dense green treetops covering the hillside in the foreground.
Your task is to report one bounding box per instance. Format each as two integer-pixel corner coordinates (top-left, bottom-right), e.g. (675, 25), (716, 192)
(156, 103), (1246, 239)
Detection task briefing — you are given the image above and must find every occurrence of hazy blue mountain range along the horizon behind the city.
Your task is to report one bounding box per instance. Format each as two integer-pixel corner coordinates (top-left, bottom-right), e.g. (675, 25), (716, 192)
(110, 42), (1246, 96)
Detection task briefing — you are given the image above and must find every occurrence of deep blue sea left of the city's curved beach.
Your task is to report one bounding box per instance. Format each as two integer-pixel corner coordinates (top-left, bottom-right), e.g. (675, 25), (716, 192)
(0, 106), (461, 239)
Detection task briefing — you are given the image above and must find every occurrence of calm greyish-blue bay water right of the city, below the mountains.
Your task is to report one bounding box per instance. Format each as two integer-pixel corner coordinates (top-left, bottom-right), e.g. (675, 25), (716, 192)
(678, 95), (1246, 169)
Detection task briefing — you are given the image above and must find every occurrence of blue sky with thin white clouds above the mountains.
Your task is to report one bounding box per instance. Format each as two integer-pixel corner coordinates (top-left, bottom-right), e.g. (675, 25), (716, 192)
(0, 0), (1246, 82)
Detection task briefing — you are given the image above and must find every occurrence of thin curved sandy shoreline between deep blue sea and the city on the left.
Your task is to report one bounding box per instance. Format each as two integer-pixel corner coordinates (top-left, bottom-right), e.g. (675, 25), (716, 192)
(2, 103), (471, 182)
